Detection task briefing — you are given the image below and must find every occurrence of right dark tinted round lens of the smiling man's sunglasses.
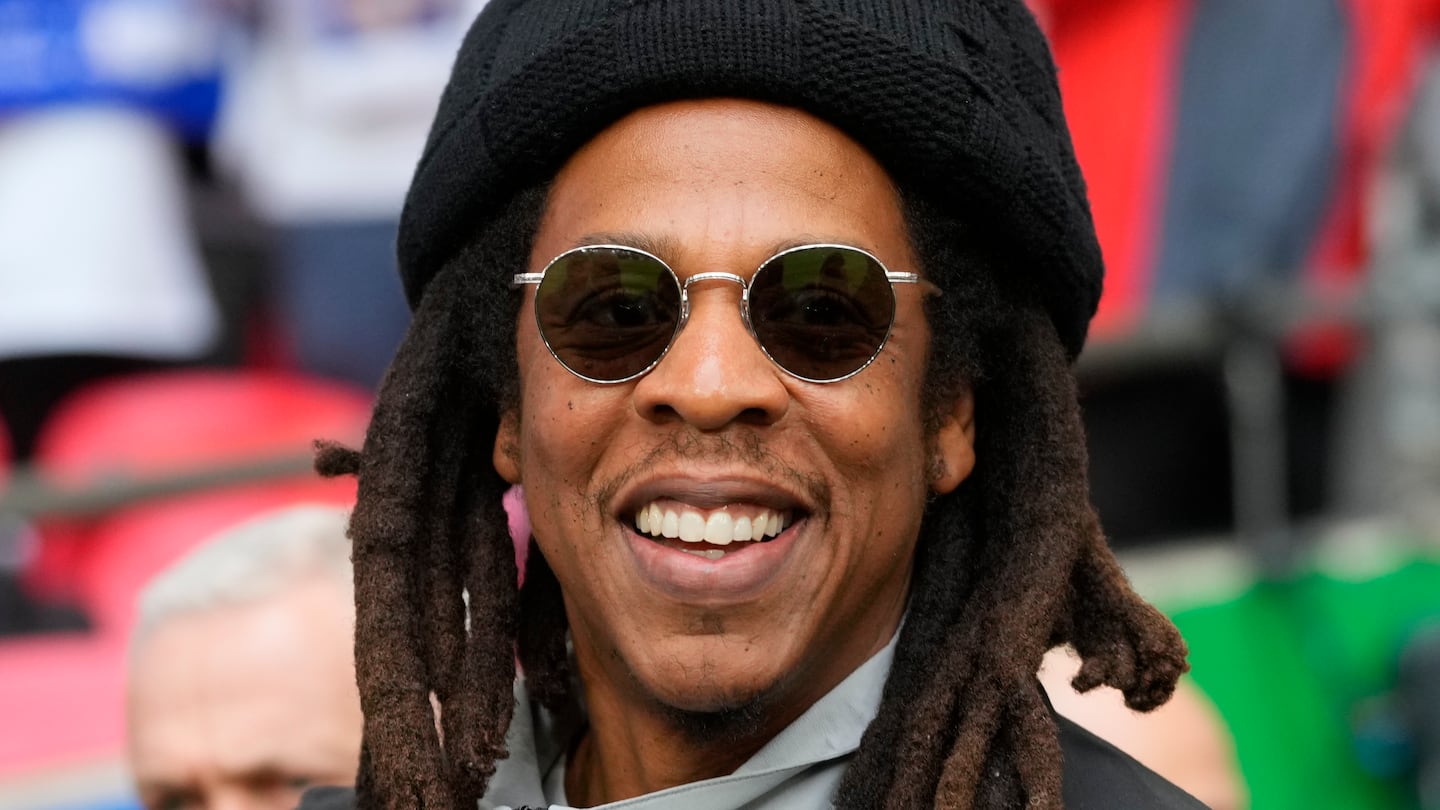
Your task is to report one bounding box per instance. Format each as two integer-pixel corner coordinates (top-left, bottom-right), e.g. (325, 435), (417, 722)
(750, 246), (896, 380)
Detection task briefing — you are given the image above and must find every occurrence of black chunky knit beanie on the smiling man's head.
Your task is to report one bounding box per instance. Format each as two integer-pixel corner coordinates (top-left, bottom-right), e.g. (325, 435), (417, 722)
(399, 0), (1103, 357)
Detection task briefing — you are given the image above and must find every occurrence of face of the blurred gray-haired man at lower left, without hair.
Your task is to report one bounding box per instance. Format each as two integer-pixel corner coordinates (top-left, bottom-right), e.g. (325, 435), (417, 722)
(127, 578), (363, 810)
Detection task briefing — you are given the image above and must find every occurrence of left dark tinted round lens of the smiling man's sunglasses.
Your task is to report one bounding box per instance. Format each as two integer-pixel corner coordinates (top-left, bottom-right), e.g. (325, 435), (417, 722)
(536, 248), (680, 382)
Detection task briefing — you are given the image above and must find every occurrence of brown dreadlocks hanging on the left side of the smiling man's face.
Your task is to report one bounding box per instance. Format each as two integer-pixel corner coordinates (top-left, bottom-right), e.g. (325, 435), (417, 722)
(317, 183), (544, 809)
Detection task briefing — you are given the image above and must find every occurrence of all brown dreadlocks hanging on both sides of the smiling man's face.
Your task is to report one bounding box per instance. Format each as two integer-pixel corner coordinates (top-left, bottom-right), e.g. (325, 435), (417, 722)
(317, 179), (1185, 810)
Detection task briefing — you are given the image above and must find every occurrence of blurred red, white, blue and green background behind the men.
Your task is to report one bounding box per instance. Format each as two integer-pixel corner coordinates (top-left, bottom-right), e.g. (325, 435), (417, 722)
(0, 0), (1440, 810)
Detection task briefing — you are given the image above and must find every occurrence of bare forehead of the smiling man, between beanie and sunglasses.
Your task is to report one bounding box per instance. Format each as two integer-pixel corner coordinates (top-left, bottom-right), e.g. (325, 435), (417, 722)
(531, 99), (910, 270)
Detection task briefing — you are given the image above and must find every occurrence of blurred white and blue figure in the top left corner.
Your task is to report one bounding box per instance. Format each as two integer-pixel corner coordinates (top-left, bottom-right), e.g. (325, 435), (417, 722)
(0, 0), (219, 461)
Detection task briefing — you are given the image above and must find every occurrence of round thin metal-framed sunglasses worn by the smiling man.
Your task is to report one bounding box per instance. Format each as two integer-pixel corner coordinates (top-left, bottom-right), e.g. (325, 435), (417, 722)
(511, 245), (939, 383)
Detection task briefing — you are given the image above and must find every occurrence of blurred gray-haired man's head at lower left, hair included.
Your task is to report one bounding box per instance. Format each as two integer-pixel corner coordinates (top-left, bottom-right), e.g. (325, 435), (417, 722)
(127, 506), (361, 810)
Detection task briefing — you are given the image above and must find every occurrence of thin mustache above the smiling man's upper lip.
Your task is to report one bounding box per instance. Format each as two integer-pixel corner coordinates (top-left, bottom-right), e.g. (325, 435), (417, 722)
(595, 431), (831, 512)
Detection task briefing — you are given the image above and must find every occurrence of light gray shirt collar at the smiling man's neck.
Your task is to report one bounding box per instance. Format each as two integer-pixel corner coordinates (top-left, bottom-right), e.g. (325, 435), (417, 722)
(480, 638), (896, 810)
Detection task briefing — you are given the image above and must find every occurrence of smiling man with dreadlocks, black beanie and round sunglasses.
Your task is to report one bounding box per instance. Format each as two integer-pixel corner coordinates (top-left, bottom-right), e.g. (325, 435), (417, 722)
(310, 0), (1195, 809)
